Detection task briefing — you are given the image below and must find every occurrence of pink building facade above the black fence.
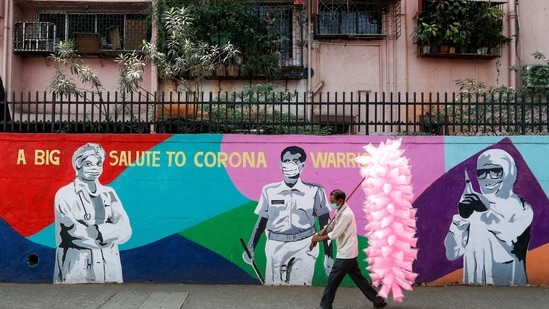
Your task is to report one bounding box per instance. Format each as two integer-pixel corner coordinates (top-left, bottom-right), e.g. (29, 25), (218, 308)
(0, 0), (549, 94)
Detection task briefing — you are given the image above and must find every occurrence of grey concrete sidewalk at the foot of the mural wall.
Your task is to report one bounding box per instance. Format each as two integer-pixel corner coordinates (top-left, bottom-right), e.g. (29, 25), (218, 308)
(0, 283), (549, 309)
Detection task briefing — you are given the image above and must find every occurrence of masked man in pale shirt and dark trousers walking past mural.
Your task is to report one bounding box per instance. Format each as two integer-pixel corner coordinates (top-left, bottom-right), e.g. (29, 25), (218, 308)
(311, 189), (387, 309)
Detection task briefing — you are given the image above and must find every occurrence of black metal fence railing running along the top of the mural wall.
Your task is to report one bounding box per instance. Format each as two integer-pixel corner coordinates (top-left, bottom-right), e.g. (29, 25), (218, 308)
(0, 92), (549, 135)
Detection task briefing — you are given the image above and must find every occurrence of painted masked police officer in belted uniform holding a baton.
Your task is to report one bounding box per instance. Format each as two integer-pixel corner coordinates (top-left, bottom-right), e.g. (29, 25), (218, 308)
(243, 146), (333, 285)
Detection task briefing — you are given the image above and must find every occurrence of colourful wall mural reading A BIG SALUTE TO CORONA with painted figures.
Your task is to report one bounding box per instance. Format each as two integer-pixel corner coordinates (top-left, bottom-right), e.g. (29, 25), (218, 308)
(0, 134), (549, 285)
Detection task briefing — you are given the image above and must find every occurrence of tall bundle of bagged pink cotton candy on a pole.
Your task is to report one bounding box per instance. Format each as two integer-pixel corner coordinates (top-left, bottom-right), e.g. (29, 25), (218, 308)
(356, 139), (417, 302)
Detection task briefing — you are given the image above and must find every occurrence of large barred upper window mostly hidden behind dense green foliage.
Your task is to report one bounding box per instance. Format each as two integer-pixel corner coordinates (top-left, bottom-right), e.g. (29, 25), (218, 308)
(183, 0), (306, 79)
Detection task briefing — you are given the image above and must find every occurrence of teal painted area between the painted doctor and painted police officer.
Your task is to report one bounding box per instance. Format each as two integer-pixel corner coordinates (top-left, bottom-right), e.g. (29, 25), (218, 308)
(112, 135), (248, 248)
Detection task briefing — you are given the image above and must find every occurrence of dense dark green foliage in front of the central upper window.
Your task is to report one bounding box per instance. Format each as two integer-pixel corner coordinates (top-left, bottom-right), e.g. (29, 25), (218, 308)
(152, 0), (288, 80)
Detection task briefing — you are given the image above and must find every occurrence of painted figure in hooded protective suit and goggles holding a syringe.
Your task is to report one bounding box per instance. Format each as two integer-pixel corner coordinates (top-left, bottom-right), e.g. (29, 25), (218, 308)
(444, 149), (534, 285)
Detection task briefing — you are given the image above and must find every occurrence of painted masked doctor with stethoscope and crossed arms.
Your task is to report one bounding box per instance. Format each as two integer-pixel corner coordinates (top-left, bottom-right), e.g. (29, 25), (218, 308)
(53, 143), (132, 283)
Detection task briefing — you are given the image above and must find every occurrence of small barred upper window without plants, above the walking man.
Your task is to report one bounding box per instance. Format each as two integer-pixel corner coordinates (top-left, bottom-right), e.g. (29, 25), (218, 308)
(315, 0), (386, 37)
